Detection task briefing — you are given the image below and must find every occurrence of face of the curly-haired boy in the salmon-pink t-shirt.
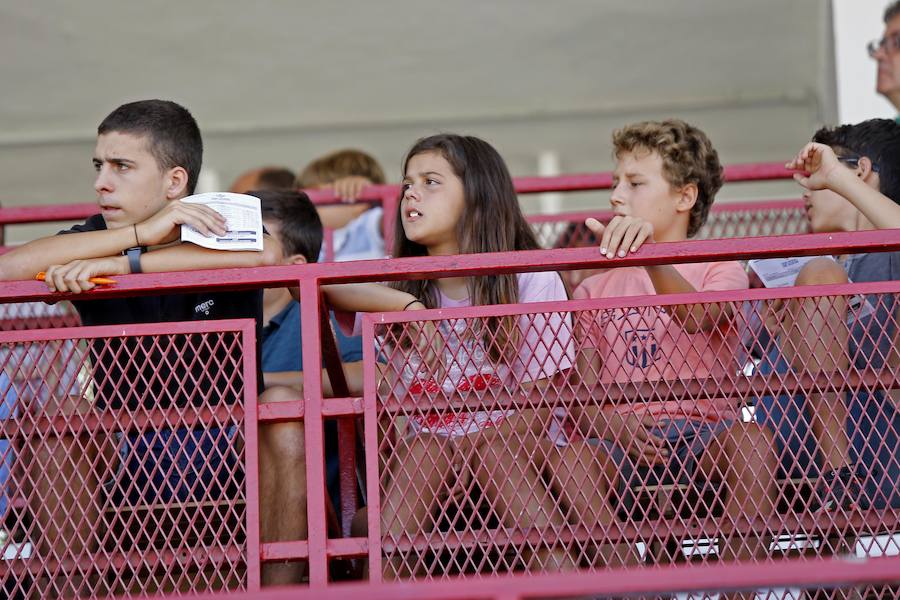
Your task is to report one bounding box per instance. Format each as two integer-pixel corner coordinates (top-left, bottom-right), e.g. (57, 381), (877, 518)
(610, 149), (687, 242)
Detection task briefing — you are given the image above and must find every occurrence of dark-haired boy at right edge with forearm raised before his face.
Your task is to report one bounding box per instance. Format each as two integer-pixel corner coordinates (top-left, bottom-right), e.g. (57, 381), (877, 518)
(756, 119), (900, 510)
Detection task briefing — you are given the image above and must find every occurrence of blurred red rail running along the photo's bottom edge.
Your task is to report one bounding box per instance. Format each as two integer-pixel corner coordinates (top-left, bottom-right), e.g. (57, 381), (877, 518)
(179, 556), (900, 600)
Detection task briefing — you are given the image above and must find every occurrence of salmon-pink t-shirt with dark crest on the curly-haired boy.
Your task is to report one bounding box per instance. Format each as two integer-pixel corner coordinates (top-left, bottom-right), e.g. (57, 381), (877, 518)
(573, 261), (749, 421)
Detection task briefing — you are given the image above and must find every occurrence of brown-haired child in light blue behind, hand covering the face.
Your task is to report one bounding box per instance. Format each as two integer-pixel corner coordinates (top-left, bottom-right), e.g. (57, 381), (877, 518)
(297, 150), (384, 261)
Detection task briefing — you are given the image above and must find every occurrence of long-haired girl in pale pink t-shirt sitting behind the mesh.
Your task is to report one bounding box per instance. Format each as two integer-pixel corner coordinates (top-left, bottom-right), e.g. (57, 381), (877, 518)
(325, 134), (574, 579)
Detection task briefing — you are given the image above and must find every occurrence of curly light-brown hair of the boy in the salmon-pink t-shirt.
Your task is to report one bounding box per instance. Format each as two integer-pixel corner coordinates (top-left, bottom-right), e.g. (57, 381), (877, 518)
(613, 119), (723, 237)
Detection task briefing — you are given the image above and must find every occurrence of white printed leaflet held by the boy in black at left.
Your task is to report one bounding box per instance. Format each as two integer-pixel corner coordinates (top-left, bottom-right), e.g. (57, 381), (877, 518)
(181, 192), (263, 251)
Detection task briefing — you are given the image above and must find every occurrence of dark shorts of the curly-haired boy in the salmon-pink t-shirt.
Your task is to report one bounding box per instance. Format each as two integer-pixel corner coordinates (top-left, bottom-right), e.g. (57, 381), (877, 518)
(588, 419), (732, 512)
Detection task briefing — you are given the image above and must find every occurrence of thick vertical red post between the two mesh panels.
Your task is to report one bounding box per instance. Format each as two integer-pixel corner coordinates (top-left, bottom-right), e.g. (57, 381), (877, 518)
(300, 279), (328, 587)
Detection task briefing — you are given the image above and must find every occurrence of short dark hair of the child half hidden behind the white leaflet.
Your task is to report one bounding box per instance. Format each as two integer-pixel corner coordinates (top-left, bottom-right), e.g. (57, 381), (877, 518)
(247, 190), (322, 263)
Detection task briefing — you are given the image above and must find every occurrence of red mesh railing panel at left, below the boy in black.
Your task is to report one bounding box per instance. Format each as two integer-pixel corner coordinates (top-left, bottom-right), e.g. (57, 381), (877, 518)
(0, 320), (260, 597)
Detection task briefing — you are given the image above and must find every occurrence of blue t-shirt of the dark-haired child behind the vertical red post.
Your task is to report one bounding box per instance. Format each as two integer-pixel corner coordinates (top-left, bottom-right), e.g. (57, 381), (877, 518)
(262, 302), (362, 373)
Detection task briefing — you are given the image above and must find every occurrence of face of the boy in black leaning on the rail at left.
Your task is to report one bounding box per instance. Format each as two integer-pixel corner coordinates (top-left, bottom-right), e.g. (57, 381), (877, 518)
(93, 131), (171, 229)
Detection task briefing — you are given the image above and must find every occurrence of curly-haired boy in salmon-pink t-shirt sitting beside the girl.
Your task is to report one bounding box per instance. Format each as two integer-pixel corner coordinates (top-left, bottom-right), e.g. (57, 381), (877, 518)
(555, 120), (775, 576)
